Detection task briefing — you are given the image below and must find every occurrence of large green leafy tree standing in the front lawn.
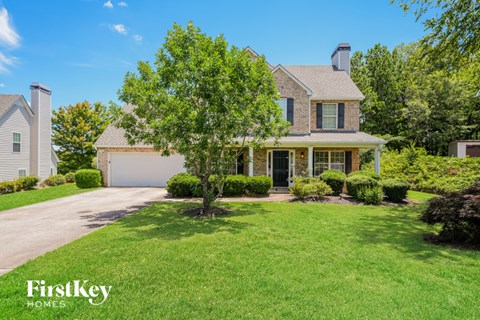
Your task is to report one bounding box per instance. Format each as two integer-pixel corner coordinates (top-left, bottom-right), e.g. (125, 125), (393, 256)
(118, 23), (287, 215)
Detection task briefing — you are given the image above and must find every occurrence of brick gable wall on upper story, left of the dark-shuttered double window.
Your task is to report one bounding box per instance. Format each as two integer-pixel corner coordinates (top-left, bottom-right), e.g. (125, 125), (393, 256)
(274, 69), (310, 134)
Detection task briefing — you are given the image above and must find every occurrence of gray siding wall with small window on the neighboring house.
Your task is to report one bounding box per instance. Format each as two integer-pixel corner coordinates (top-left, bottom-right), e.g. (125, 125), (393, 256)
(0, 104), (32, 181)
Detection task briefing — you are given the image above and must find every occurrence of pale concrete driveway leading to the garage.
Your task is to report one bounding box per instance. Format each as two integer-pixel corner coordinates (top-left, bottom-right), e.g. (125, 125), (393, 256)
(0, 188), (166, 275)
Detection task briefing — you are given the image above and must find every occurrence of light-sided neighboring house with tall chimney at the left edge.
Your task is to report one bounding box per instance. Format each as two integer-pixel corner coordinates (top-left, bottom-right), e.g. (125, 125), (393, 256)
(0, 82), (58, 181)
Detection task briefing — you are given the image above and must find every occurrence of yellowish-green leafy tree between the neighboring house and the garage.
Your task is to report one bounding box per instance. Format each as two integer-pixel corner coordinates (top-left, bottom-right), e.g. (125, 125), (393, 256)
(52, 101), (111, 174)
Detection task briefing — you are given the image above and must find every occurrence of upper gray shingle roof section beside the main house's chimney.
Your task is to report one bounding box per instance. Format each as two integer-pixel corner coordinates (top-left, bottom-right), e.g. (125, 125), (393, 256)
(284, 65), (365, 100)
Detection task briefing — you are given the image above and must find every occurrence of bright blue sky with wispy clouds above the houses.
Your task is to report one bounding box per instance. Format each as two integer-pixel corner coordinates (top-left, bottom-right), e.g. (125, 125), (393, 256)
(0, 0), (424, 108)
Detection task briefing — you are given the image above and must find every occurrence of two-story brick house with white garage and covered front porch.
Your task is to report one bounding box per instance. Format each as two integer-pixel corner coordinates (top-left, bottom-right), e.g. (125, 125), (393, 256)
(95, 43), (386, 187)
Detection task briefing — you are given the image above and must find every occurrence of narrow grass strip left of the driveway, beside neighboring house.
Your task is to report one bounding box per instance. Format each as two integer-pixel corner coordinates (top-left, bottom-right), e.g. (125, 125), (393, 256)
(0, 183), (98, 211)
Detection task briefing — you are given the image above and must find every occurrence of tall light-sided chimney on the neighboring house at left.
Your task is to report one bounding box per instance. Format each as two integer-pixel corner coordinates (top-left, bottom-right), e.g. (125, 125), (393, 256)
(30, 82), (52, 180)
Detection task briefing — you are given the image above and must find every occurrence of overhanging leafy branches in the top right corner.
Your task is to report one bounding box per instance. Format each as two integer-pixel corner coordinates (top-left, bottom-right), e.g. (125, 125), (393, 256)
(391, 0), (480, 64)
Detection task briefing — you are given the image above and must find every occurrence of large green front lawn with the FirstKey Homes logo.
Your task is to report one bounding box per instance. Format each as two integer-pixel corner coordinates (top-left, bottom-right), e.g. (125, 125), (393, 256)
(0, 193), (480, 319)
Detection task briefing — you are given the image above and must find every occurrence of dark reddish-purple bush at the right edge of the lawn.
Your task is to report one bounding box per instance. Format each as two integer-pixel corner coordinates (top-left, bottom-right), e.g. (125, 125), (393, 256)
(420, 182), (480, 245)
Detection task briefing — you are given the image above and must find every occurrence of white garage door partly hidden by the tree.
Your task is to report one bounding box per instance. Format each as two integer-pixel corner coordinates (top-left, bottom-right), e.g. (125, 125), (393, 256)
(110, 152), (185, 187)
